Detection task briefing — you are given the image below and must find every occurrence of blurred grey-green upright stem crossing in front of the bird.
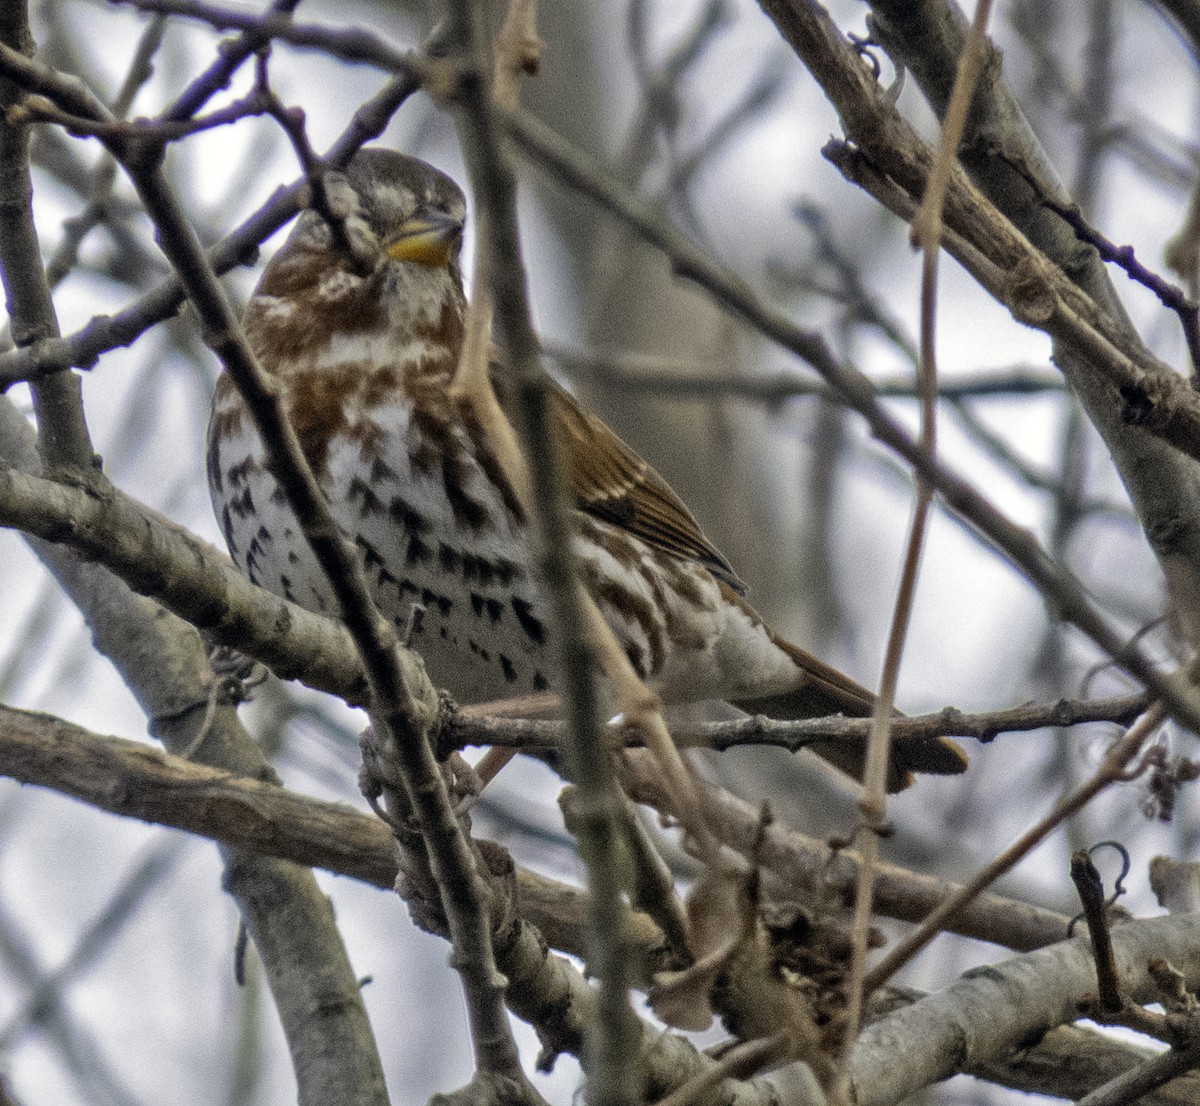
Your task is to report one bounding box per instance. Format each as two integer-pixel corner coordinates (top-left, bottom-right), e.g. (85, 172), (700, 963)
(441, 0), (644, 1106)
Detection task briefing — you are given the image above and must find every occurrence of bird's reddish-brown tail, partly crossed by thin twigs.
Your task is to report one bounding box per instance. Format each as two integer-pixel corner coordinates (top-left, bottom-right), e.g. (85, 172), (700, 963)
(733, 635), (967, 792)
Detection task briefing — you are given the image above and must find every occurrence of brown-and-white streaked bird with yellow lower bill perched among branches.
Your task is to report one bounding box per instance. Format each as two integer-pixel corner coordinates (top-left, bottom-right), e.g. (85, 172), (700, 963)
(208, 146), (966, 791)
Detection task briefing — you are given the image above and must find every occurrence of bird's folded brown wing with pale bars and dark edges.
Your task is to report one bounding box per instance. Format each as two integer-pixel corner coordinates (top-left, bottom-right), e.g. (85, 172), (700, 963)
(550, 384), (745, 594)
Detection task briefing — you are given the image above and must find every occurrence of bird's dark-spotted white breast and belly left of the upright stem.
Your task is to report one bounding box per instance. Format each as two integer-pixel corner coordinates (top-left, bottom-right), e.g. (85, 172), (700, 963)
(210, 369), (550, 702)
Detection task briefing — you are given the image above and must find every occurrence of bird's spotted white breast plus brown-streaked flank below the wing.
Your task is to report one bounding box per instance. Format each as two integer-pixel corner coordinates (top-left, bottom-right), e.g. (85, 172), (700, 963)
(210, 335), (786, 702)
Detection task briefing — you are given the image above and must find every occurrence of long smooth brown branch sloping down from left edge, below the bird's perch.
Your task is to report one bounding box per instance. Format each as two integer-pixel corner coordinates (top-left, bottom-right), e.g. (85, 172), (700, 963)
(0, 707), (1069, 954)
